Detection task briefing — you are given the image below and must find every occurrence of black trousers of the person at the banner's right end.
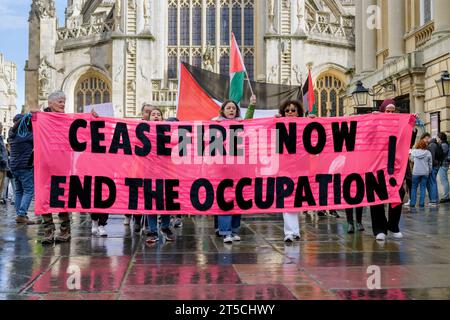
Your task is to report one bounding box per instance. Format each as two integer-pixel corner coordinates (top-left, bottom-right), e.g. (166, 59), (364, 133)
(370, 187), (406, 236)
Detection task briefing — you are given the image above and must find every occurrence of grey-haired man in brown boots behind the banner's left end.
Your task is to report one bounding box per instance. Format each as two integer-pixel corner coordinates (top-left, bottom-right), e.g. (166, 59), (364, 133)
(41, 91), (71, 244)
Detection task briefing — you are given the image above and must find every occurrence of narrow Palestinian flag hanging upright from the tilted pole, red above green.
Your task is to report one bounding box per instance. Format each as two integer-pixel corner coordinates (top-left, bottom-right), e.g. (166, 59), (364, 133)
(229, 33), (247, 103)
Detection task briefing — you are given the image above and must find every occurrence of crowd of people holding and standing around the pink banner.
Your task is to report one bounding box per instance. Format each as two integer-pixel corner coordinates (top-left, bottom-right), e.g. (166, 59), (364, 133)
(0, 91), (450, 245)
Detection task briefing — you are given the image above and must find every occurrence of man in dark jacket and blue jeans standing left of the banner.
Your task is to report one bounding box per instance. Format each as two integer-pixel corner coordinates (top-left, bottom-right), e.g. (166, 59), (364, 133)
(8, 114), (35, 224)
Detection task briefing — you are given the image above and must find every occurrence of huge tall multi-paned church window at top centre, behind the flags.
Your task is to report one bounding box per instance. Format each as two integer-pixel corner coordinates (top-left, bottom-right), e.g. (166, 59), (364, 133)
(167, 0), (255, 79)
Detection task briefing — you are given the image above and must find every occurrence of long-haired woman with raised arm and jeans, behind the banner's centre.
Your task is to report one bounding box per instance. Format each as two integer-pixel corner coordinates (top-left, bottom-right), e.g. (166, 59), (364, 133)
(212, 95), (256, 244)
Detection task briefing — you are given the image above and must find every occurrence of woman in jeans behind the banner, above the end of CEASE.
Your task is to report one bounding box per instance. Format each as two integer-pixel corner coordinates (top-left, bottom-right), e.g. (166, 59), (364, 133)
(145, 108), (175, 244)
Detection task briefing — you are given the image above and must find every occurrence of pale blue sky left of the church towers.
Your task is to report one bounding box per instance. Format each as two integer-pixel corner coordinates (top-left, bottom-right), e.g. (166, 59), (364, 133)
(0, 0), (67, 110)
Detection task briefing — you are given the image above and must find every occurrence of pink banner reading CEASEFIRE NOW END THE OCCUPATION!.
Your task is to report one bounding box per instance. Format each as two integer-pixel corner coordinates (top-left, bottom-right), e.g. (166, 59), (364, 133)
(33, 113), (415, 215)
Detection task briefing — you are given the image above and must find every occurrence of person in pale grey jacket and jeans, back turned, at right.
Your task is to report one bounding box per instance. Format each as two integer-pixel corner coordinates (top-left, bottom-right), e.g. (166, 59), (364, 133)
(410, 140), (432, 208)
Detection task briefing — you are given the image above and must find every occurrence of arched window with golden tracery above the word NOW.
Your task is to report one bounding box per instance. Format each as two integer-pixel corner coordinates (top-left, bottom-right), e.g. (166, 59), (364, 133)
(316, 74), (345, 117)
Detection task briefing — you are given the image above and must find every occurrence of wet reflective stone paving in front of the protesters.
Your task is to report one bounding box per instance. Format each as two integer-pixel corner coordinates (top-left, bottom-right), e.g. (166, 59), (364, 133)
(0, 204), (450, 300)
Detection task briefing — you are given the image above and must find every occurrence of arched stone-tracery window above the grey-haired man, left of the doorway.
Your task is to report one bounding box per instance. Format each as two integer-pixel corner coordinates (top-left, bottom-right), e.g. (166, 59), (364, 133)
(75, 72), (111, 113)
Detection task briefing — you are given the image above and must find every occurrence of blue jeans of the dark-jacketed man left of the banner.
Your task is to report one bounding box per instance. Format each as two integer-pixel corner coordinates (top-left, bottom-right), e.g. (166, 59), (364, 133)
(12, 169), (34, 217)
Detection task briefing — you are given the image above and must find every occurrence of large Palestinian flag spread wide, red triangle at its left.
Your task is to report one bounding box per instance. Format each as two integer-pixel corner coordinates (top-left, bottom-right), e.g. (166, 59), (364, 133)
(177, 62), (302, 121)
